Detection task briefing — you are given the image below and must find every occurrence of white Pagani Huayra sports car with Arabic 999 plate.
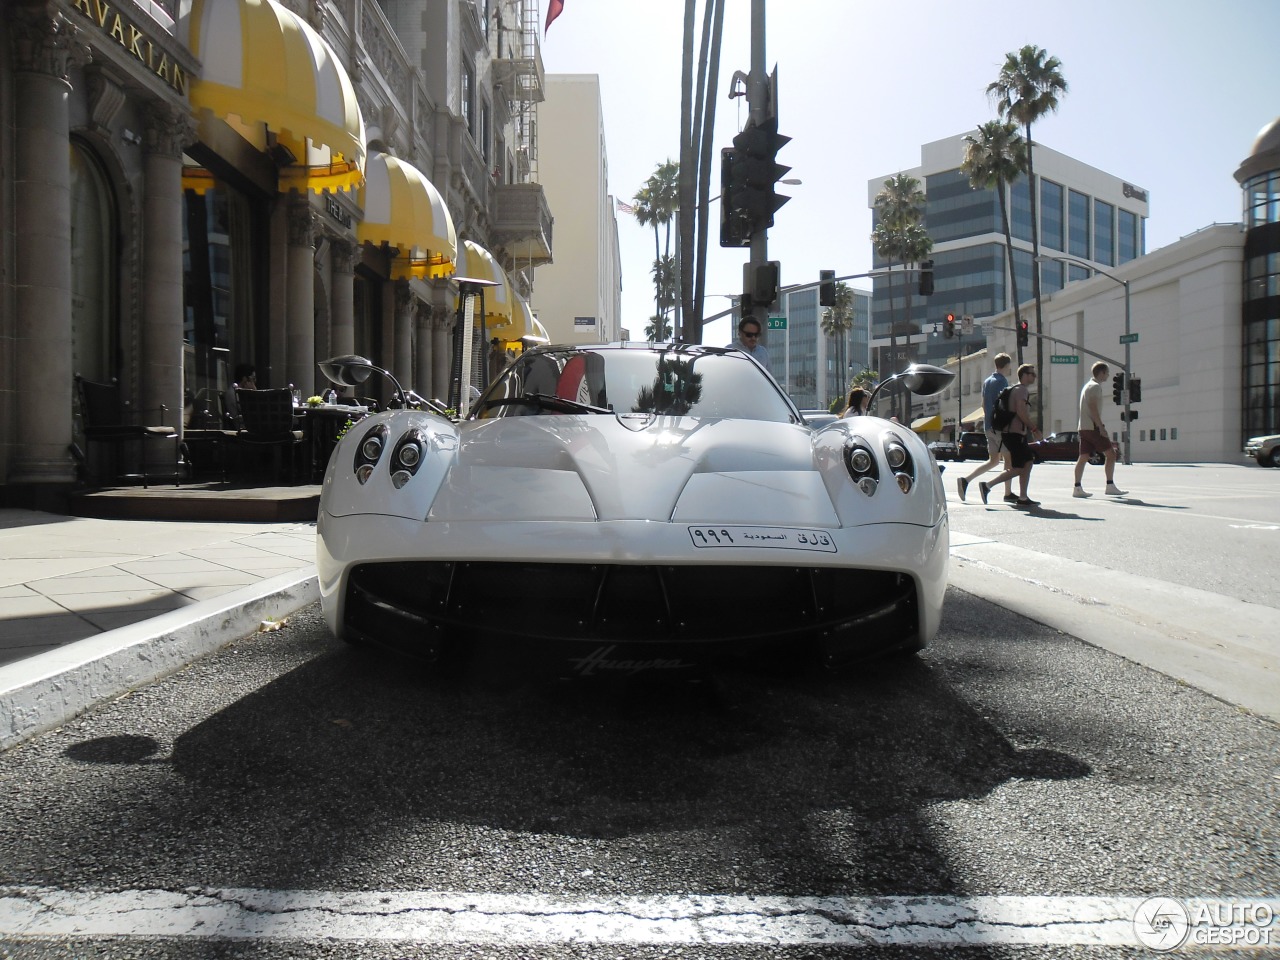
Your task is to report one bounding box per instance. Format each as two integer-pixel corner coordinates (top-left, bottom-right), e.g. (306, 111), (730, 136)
(316, 343), (950, 676)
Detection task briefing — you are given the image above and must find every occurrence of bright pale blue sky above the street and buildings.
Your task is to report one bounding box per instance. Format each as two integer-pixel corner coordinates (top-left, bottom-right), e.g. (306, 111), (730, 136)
(535, 0), (1280, 343)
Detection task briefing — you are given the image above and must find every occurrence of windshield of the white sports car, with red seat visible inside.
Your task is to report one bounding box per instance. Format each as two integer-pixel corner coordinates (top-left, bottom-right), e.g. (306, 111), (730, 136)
(474, 347), (796, 422)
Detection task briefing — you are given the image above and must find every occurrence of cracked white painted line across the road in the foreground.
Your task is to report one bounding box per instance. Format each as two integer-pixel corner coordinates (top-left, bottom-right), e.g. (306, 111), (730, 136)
(0, 887), (1280, 947)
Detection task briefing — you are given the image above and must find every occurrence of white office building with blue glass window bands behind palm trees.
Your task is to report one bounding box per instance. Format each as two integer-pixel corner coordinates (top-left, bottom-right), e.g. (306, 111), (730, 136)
(867, 134), (1148, 374)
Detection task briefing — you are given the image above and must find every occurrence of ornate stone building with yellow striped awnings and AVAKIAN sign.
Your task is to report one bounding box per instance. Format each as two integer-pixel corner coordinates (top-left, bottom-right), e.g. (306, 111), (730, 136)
(0, 0), (552, 493)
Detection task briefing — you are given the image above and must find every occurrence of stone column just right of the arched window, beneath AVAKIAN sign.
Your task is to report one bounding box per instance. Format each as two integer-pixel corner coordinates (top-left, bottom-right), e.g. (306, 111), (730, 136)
(140, 102), (195, 474)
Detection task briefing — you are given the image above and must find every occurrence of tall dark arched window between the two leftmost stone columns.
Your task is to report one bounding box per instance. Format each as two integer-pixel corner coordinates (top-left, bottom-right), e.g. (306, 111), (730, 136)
(70, 140), (120, 381)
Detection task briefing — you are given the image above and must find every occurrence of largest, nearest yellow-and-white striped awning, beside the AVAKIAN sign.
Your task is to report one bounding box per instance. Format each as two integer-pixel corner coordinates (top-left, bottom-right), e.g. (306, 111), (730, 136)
(178, 0), (365, 192)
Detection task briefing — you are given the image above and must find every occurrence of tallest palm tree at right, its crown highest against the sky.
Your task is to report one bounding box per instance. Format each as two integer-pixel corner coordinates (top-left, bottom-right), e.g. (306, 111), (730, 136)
(987, 44), (1066, 391)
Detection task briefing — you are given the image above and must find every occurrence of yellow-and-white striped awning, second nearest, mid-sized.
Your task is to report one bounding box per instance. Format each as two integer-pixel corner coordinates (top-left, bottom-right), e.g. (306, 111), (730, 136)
(356, 150), (458, 280)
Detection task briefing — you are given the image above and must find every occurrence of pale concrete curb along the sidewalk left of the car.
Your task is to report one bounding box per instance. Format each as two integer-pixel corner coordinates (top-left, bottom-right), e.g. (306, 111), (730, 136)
(0, 567), (320, 750)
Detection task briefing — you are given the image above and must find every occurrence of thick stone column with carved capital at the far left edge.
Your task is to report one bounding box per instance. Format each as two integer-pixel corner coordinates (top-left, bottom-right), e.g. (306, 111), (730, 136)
(5, 3), (88, 484)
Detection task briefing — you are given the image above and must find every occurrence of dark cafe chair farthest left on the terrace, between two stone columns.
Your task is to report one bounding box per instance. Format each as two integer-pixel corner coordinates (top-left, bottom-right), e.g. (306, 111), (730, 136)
(76, 374), (183, 486)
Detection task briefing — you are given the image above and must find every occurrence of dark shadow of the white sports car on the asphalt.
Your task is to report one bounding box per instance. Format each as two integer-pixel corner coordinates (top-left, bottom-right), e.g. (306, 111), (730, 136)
(40, 631), (1091, 893)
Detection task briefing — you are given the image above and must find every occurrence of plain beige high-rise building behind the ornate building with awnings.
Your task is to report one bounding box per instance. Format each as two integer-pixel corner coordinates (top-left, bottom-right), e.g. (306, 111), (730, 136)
(538, 73), (625, 343)
